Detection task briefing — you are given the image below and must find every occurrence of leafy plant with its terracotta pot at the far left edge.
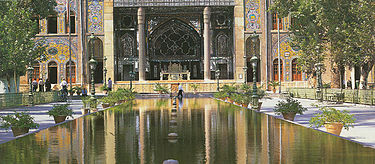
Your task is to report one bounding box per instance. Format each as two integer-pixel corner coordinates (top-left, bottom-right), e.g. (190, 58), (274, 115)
(0, 111), (39, 137)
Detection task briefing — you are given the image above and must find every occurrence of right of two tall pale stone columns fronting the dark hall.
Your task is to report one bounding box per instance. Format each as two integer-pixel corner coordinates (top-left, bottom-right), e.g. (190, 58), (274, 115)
(203, 7), (211, 81)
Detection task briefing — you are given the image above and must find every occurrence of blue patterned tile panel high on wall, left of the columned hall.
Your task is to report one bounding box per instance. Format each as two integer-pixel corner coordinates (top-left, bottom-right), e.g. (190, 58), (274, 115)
(87, 0), (103, 33)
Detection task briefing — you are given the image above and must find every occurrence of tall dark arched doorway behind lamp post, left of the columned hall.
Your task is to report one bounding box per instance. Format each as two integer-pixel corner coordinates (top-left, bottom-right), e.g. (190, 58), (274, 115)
(87, 37), (104, 83)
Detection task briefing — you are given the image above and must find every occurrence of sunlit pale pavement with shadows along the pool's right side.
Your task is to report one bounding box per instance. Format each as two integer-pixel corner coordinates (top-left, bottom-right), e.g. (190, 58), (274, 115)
(261, 93), (375, 148)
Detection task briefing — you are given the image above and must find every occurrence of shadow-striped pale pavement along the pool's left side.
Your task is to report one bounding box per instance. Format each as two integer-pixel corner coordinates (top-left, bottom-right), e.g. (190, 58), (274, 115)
(0, 100), (103, 144)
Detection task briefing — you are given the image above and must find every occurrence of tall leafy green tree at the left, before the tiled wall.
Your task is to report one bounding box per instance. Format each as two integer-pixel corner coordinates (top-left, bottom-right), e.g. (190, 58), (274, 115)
(0, 0), (56, 92)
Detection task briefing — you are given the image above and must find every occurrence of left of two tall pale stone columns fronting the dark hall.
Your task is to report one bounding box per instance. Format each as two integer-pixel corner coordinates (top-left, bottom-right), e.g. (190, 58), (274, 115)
(138, 7), (146, 81)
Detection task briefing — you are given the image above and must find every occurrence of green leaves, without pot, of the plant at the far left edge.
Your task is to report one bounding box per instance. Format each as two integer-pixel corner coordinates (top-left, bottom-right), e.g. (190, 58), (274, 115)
(0, 111), (39, 129)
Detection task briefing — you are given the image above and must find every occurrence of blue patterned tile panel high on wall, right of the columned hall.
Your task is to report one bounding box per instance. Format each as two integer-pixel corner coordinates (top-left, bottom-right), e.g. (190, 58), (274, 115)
(245, 0), (260, 31)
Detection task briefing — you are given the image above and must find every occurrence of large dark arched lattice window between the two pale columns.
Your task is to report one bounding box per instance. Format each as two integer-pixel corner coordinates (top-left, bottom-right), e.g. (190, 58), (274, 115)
(147, 18), (203, 80)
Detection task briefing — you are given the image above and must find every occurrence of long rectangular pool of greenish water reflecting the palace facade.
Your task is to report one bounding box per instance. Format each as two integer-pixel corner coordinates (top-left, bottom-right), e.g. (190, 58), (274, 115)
(0, 98), (375, 164)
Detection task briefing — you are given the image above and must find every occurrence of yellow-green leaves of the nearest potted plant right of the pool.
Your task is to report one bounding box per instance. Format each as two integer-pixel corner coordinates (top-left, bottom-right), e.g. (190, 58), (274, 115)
(310, 107), (356, 130)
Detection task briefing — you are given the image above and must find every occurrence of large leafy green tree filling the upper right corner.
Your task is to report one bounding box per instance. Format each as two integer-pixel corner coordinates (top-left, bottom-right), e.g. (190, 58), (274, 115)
(271, 0), (375, 87)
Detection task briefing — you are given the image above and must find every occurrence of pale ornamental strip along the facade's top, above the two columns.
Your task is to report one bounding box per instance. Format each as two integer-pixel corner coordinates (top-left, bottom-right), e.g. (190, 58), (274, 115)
(113, 0), (234, 7)
